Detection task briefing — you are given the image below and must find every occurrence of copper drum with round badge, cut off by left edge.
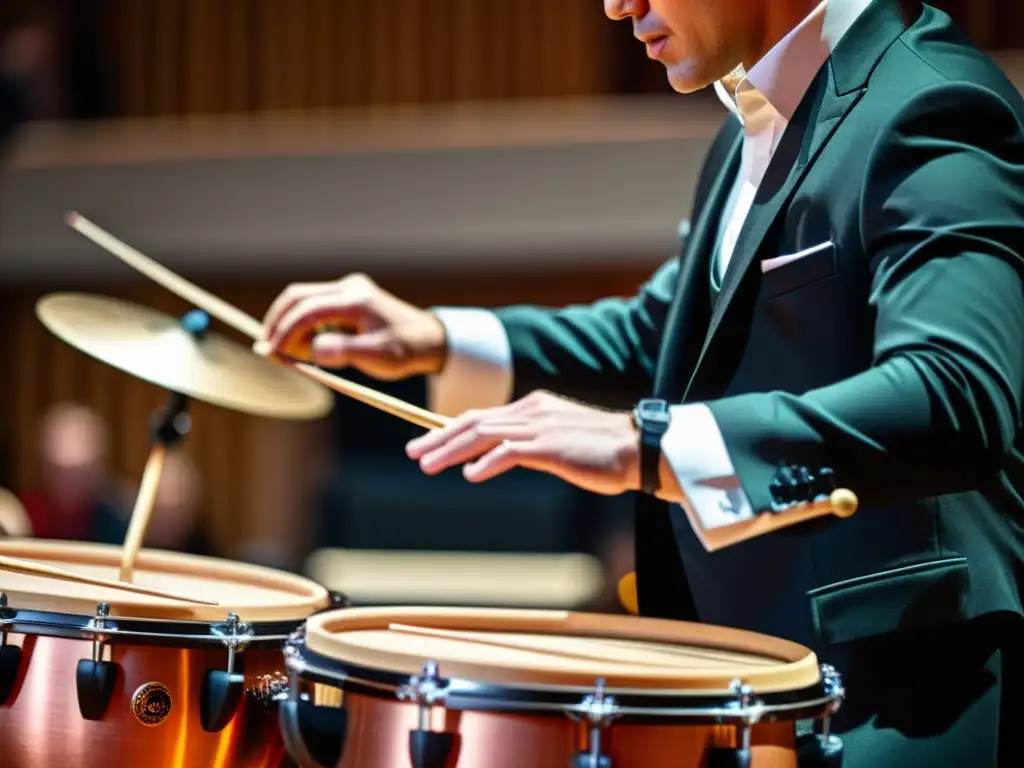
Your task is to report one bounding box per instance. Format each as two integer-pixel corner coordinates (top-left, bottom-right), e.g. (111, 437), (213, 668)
(0, 540), (337, 768)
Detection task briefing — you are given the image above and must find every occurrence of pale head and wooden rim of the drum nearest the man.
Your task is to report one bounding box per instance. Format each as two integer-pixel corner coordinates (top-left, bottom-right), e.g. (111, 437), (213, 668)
(305, 608), (820, 695)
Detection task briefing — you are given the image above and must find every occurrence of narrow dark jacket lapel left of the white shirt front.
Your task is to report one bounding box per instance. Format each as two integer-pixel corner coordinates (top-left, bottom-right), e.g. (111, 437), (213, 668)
(654, 130), (743, 399)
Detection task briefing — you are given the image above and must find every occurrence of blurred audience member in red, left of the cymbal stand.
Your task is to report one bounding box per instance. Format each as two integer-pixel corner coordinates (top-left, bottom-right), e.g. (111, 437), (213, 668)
(22, 403), (128, 544)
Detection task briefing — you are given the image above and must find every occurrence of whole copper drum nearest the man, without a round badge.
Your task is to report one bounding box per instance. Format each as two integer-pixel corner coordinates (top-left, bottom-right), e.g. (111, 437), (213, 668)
(280, 608), (843, 768)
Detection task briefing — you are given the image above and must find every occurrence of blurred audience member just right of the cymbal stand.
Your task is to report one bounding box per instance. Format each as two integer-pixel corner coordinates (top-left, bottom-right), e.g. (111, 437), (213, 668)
(145, 451), (212, 555)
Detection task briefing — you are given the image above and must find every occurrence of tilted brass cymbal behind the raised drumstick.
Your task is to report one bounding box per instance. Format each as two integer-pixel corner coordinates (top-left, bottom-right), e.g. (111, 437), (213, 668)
(36, 293), (334, 421)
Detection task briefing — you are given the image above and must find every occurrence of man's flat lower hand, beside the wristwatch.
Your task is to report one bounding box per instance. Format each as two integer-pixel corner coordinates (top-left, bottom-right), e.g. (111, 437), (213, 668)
(406, 391), (640, 496)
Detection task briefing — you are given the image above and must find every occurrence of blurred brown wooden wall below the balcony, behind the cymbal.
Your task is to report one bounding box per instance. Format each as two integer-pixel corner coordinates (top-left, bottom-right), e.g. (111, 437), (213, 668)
(0, 267), (648, 556)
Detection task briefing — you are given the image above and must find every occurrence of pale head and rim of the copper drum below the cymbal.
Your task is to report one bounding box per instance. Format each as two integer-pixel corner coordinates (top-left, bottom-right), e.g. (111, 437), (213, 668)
(0, 540), (330, 623)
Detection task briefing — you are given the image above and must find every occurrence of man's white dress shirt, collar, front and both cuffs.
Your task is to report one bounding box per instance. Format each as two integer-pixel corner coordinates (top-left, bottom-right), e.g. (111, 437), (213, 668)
(428, 0), (870, 527)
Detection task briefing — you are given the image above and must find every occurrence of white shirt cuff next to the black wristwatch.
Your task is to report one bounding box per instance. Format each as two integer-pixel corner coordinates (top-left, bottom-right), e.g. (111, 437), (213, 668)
(662, 403), (754, 536)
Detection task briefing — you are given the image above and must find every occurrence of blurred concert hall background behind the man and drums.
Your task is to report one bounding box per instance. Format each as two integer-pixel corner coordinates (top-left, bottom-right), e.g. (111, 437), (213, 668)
(0, 0), (1024, 610)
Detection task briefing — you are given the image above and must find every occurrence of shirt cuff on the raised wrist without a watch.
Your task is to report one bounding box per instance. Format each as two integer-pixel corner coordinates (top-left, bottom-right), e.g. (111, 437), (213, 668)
(427, 307), (512, 416)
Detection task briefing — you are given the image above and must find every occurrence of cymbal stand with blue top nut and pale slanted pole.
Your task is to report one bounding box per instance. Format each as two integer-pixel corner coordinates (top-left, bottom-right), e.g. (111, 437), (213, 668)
(118, 310), (210, 583)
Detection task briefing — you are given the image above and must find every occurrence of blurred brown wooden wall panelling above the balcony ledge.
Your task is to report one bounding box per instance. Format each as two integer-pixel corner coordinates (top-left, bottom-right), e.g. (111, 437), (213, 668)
(94, 0), (614, 116)
